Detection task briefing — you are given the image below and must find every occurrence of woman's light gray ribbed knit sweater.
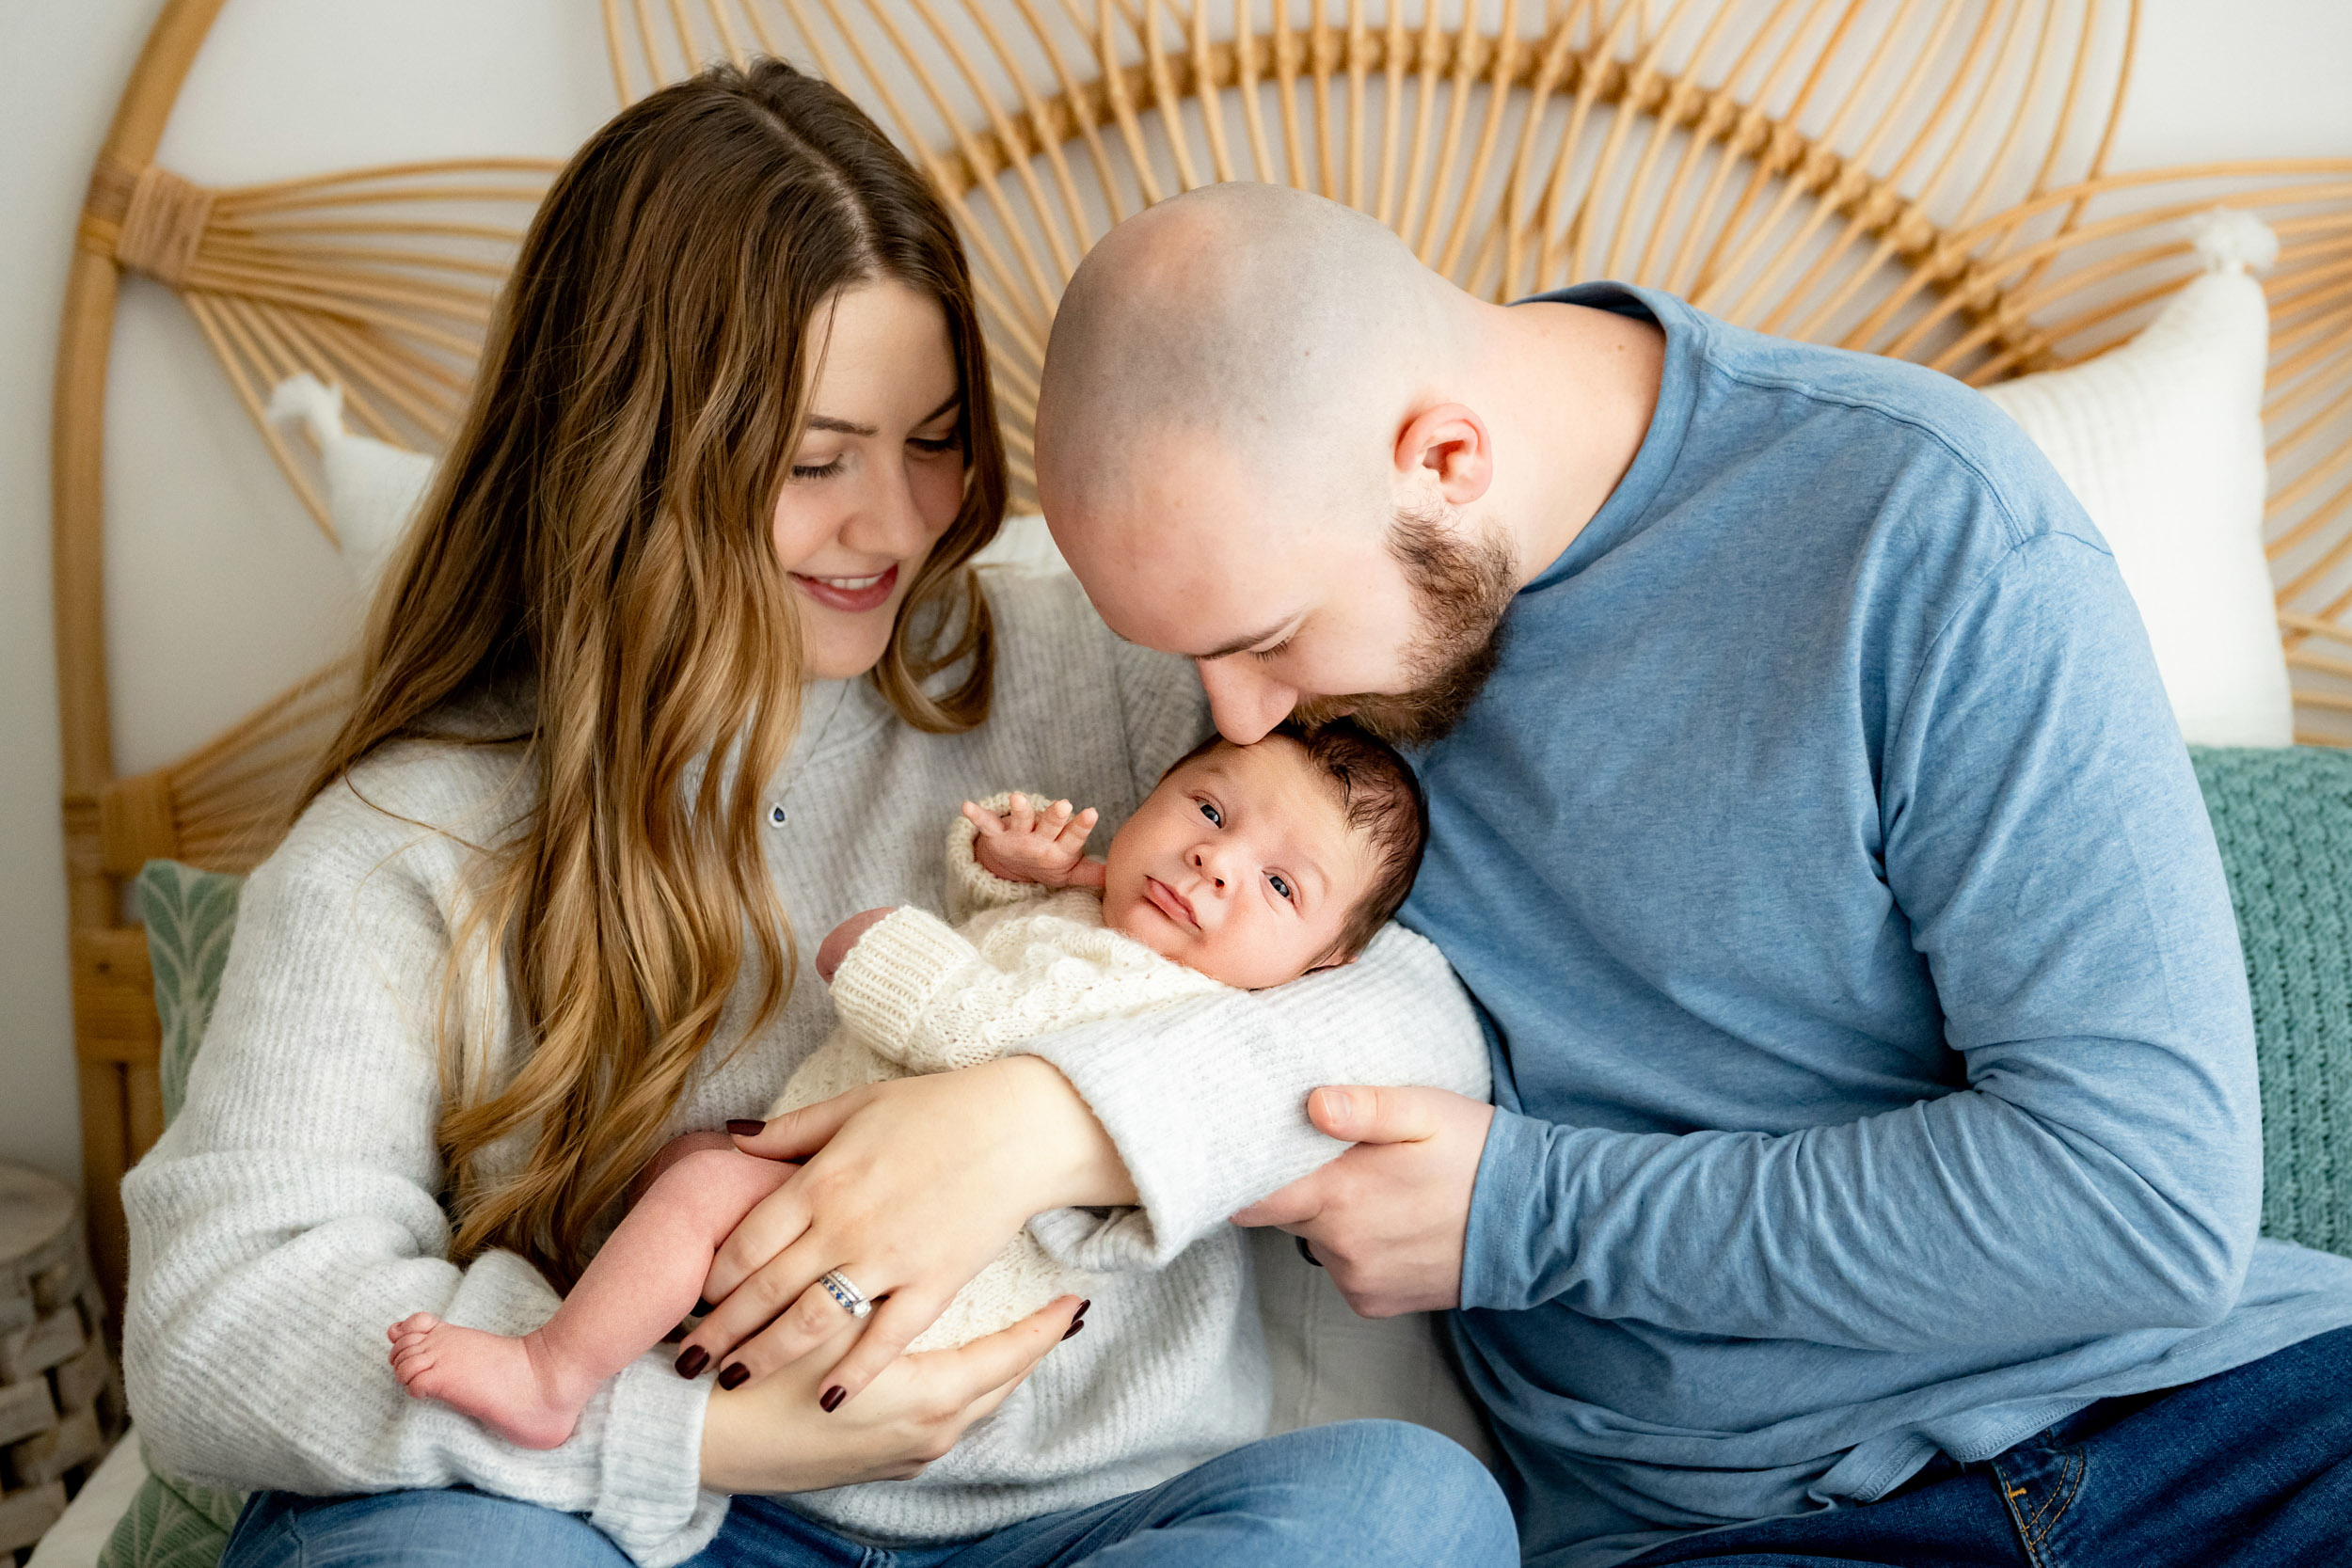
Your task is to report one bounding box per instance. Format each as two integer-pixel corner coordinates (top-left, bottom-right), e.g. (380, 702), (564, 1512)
(125, 576), (1485, 1568)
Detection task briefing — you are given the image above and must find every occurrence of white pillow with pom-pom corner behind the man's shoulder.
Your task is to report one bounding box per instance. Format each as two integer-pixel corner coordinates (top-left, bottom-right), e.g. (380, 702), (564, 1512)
(1985, 209), (2296, 745)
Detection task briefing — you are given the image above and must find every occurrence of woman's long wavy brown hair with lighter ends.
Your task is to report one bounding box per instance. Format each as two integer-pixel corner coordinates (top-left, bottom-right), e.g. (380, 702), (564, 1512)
(310, 61), (1005, 1286)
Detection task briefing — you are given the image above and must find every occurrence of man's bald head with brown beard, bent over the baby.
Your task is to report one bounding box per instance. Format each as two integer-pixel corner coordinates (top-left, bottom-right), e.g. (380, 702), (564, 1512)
(1038, 183), (1515, 743)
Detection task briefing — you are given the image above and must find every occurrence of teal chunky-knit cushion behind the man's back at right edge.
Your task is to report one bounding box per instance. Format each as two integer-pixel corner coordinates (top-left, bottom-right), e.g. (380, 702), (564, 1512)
(2190, 745), (2352, 1256)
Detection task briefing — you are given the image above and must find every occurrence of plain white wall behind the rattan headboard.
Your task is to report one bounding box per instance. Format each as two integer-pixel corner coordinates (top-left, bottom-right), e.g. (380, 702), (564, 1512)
(0, 0), (2352, 1180)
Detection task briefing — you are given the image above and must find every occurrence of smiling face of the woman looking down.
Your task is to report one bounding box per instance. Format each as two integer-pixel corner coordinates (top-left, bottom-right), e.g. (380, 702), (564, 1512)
(774, 282), (964, 679)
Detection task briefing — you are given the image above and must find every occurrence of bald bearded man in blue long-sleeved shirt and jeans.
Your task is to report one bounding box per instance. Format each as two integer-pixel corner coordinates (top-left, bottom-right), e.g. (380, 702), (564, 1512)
(1038, 185), (2352, 1568)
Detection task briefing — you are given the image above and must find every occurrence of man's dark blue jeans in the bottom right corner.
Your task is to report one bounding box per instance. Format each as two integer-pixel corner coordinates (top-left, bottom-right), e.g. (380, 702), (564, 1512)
(1626, 1328), (2352, 1568)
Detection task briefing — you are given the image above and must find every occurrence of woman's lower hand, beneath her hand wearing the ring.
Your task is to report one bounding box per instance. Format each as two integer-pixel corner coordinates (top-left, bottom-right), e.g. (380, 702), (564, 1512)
(704, 1295), (1080, 1493)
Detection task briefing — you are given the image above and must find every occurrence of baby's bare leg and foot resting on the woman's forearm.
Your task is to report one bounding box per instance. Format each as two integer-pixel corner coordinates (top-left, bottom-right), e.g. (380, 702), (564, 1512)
(390, 1133), (798, 1449)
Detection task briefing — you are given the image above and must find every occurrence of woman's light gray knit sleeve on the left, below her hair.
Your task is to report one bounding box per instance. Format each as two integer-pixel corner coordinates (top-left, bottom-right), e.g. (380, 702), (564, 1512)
(122, 787), (727, 1568)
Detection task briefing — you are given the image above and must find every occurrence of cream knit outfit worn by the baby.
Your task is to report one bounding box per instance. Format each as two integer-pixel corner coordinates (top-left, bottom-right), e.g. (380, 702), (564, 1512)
(767, 792), (1226, 1354)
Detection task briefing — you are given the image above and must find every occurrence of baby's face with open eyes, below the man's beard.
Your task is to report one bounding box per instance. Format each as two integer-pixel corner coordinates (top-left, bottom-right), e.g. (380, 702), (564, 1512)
(1104, 736), (1376, 990)
